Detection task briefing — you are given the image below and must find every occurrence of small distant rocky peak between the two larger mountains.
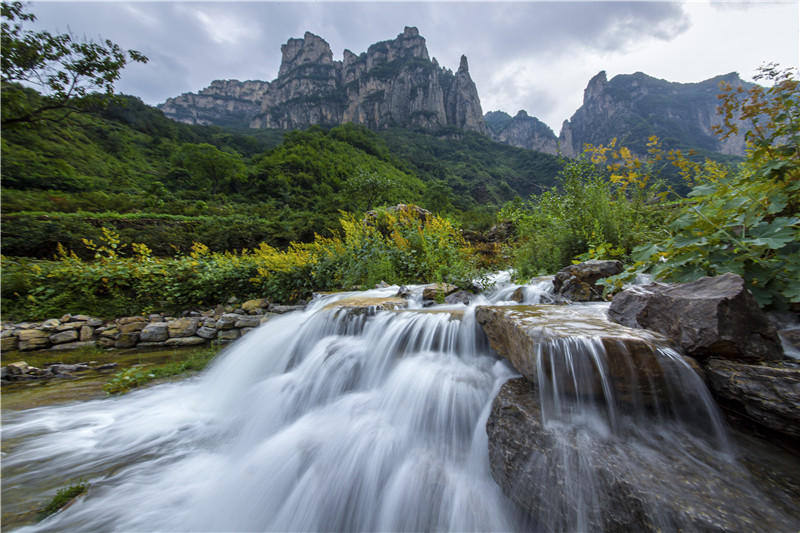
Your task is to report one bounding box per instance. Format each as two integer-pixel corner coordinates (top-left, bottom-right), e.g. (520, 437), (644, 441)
(484, 110), (559, 155)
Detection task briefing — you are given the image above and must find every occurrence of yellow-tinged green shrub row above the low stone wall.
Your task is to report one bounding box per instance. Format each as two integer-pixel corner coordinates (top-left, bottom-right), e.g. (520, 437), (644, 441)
(2, 207), (476, 319)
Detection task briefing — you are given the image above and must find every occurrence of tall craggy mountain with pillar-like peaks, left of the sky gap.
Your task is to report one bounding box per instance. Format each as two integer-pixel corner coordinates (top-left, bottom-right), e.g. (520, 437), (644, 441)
(158, 27), (487, 134)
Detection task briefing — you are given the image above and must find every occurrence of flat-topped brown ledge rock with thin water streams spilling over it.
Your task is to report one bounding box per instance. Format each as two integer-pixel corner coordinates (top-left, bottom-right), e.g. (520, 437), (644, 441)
(475, 305), (702, 410)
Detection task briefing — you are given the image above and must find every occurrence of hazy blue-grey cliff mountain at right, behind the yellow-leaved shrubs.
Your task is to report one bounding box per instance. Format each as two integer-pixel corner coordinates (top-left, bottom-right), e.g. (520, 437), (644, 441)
(559, 72), (745, 157)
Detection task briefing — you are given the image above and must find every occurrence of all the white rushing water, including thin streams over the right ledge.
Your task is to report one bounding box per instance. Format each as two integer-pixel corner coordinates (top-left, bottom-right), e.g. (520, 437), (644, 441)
(2, 280), (796, 531)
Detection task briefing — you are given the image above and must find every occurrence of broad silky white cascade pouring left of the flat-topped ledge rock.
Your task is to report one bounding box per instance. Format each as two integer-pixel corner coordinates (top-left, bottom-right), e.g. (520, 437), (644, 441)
(2, 283), (796, 531)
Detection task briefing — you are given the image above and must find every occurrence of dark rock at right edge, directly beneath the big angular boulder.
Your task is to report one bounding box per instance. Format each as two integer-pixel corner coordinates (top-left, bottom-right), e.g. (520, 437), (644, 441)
(706, 359), (800, 439)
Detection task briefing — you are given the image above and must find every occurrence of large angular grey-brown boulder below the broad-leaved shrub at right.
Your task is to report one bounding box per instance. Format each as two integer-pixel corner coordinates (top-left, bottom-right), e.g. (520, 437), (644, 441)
(608, 273), (783, 361)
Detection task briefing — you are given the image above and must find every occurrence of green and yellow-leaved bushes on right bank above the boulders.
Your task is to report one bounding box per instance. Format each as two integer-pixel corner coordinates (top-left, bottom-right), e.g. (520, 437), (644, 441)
(501, 65), (800, 308)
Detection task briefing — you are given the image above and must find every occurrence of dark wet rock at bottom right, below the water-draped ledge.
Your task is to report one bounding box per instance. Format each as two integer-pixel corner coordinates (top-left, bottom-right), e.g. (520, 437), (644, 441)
(486, 378), (800, 532)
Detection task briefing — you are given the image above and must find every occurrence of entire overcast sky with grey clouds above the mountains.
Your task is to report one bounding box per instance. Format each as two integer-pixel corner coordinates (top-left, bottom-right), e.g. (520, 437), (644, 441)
(29, 0), (800, 134)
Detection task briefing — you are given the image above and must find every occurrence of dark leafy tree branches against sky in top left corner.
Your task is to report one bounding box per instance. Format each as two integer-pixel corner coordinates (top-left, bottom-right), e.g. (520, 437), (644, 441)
(0, 2), (147, 128)
